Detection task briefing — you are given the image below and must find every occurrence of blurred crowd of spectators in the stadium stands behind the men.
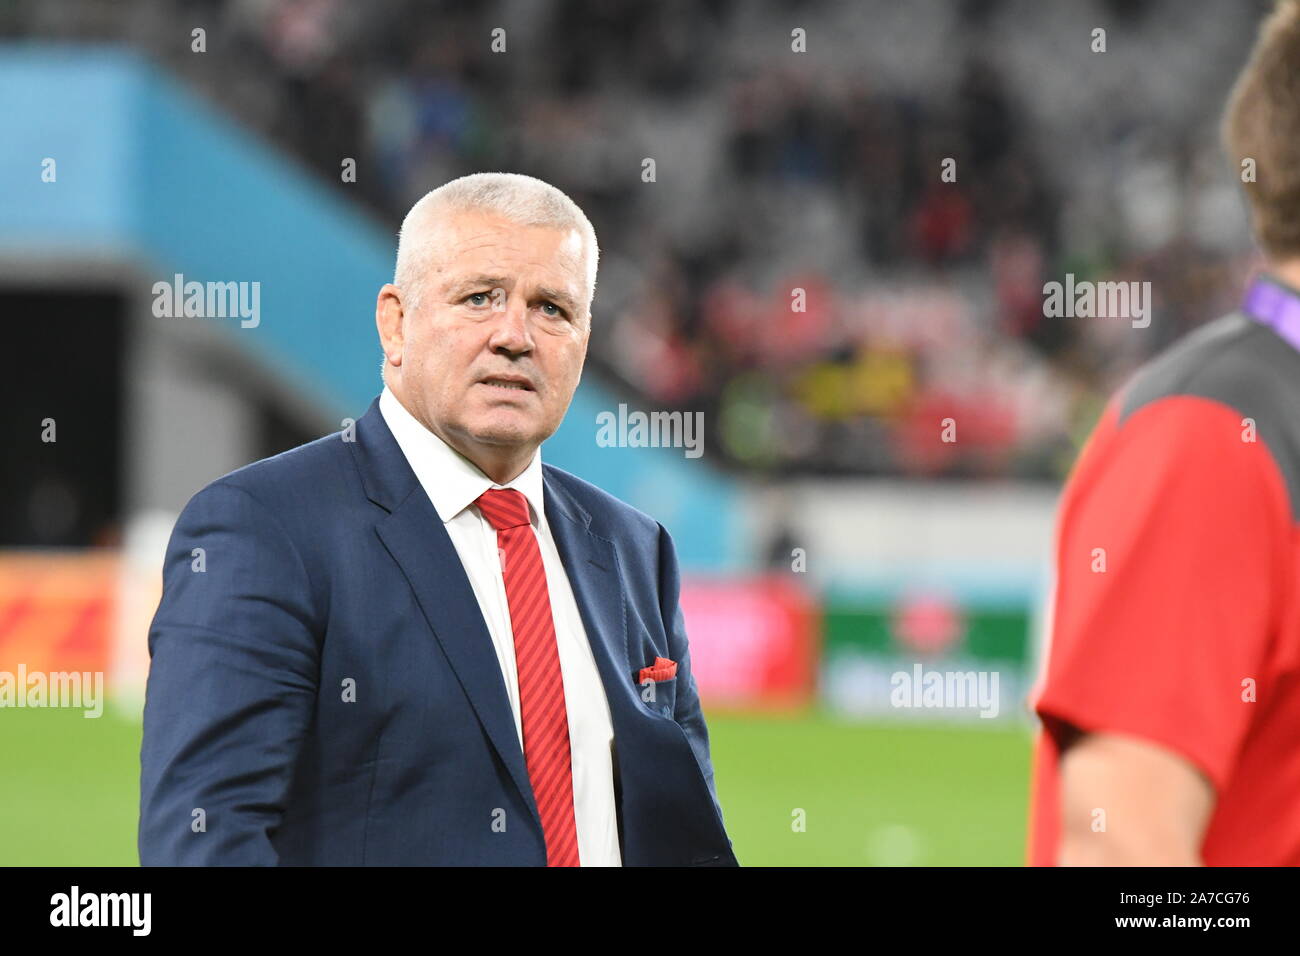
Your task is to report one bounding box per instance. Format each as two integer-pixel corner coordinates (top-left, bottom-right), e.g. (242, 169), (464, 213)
(0, 0), (1265, 479)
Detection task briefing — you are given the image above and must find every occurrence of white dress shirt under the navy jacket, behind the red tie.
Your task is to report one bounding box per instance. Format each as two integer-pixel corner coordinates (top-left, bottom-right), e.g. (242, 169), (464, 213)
(380, 386), (623, 866)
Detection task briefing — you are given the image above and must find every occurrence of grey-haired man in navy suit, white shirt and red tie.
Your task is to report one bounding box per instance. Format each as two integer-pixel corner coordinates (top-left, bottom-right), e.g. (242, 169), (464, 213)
(139, 173), (737, 866)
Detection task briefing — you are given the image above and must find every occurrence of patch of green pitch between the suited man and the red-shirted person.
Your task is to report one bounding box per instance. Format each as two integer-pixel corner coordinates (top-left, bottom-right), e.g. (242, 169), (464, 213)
(709, 714), (1032, 866)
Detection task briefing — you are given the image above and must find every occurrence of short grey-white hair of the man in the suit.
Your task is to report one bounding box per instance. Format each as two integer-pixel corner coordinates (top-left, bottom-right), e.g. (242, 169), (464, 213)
(393, 173), (601, 317)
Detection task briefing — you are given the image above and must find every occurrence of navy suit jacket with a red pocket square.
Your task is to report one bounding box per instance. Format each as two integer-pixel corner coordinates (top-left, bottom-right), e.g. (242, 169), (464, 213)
(139, 399), (737, 866)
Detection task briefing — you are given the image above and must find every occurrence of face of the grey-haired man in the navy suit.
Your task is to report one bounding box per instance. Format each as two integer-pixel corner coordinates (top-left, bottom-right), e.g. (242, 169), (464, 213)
(381, 212), (590, 471)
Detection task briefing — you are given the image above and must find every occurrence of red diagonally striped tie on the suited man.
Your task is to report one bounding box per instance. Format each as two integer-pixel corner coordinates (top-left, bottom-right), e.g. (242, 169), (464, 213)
(475, 488), (579, 866)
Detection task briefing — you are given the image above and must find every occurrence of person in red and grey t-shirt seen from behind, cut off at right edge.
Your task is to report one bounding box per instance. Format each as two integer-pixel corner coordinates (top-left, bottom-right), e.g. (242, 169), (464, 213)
(1028, 0), (1300, 865)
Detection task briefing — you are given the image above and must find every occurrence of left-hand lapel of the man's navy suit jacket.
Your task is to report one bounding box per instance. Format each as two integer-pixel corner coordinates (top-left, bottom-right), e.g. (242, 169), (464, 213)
(352, 399), (541, 827)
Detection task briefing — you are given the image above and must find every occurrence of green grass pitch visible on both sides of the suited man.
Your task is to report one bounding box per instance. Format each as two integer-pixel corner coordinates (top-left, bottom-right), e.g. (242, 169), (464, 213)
(0, 708), (1030, 866)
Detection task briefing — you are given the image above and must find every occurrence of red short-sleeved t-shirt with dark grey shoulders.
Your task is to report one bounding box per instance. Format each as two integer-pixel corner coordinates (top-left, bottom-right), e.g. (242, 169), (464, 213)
(1028, 315), (1300, 865)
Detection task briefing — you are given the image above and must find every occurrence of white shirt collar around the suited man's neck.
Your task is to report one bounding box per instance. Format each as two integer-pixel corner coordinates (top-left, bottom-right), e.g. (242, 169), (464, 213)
(380, 385), (545, 524)
